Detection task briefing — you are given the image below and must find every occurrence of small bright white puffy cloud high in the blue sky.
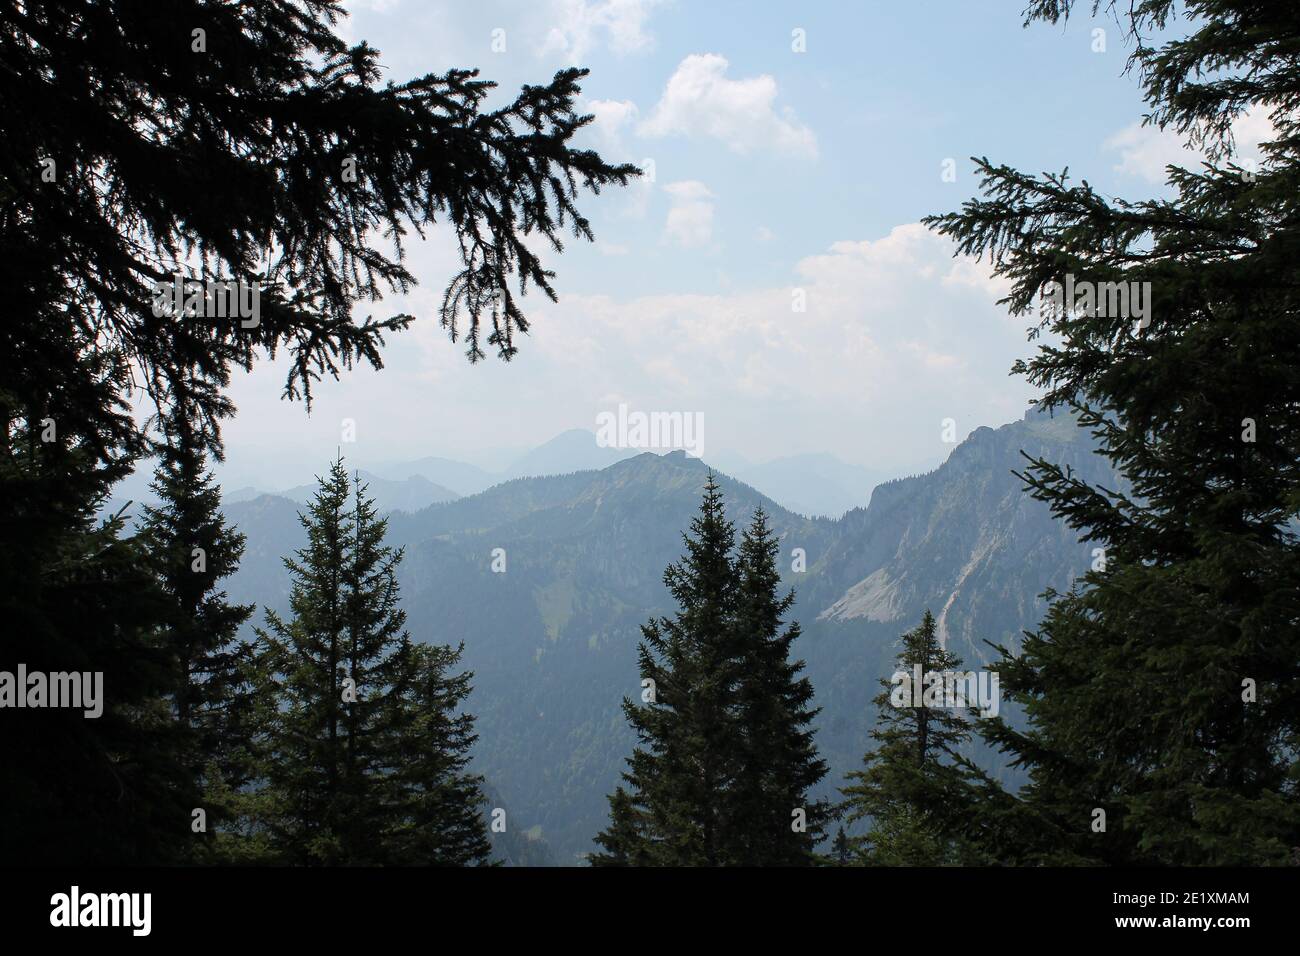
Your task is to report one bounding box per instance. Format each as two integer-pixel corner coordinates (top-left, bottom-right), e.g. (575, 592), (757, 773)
(640, 53), (816, 157)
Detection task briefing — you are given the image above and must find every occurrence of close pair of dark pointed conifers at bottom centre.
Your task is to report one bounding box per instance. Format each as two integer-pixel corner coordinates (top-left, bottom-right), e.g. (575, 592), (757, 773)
(590, 473), (829, 866)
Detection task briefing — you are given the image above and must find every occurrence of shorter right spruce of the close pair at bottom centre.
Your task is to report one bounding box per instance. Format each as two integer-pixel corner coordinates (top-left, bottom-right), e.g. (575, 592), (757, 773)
(732, 507), (831, 866)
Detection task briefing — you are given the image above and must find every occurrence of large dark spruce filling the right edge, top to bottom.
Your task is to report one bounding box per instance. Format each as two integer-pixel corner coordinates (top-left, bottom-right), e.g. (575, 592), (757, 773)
(928, 0), (1300, 865)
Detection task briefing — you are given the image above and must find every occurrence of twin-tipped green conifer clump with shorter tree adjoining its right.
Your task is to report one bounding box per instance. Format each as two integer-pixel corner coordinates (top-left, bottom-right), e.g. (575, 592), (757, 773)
(259, 459), (490, 865)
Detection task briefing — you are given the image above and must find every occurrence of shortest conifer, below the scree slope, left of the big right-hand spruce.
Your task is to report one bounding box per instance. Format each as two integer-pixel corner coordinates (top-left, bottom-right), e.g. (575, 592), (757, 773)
(841, 610), (976, 866)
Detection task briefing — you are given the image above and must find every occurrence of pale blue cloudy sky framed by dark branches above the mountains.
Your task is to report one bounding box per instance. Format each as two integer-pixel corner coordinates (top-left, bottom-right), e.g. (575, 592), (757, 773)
(205, 0), (1260, 488)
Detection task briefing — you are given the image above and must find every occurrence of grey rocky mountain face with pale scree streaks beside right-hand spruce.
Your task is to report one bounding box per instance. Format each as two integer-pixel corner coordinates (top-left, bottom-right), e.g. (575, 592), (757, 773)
(819, 411), (1115, 662)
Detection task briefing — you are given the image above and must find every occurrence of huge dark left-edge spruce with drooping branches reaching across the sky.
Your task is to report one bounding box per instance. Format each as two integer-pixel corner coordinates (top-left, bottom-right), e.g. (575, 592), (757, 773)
(0, 0), (637, 862)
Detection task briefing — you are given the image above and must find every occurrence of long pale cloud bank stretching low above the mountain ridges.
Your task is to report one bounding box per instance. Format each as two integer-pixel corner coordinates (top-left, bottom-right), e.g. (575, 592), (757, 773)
(218, 223), (1032, 486)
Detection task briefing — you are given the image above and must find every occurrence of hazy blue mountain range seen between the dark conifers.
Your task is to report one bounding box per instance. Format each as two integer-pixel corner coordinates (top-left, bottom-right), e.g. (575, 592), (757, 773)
(202, 411), (1114, 864)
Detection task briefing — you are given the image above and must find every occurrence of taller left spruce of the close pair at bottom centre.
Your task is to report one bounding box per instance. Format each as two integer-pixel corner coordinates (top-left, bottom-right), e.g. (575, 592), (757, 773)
(592, 473), (744, 866)
